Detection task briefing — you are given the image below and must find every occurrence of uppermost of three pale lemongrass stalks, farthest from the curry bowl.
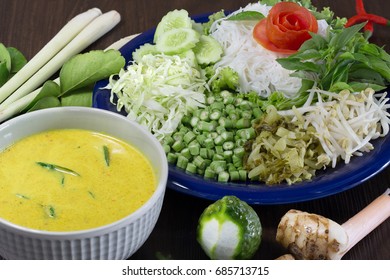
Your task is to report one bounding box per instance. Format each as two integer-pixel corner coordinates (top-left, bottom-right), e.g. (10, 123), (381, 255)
(0, 8), (102, 102)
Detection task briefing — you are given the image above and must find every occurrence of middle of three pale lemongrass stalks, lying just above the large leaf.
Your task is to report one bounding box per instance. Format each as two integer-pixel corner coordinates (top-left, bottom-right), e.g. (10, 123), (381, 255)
(0, 11), (120, 109)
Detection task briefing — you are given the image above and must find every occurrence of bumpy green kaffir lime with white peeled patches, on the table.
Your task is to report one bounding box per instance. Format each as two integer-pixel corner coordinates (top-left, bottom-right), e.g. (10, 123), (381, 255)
(197, 196), (262, 259)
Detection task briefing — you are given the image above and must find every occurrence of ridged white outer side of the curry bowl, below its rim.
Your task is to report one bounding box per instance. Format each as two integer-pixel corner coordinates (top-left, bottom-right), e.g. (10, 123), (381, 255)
(0, 194), (163, 260)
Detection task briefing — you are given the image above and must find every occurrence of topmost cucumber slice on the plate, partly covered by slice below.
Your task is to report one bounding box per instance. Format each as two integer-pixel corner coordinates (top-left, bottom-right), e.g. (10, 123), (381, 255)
(153, 10), (192, 43)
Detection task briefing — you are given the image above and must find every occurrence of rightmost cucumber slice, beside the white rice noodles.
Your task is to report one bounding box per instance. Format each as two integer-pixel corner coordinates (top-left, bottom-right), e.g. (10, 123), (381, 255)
(194, 35), (223, 65)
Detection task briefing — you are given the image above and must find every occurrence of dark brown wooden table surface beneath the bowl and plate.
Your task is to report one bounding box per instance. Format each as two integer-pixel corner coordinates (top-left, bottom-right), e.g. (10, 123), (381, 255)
(0, 0), (390, 260)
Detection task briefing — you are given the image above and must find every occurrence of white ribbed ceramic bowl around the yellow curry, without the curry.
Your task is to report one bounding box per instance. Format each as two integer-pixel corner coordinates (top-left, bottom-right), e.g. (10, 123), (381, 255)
(0, 107), (168, 260)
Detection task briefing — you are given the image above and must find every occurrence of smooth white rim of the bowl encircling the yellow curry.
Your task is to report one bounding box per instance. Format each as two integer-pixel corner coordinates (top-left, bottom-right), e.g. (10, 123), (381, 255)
(0, 106), (168, 239)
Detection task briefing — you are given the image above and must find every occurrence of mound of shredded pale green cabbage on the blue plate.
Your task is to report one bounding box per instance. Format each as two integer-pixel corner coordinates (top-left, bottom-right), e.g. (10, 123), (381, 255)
(107, 54), (206, 140)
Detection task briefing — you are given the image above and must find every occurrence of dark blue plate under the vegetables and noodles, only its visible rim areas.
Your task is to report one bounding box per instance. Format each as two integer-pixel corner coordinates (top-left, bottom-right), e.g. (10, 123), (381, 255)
(93, 15), (390, 205)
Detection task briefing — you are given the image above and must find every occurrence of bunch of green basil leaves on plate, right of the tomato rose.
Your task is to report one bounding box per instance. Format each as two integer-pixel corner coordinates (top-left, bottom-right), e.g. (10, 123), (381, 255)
(278, 23), (390, 92)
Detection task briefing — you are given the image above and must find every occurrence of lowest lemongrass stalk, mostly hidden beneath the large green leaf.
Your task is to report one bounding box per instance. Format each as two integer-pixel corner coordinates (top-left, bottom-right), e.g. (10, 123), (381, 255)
(0, 34), (138, 123)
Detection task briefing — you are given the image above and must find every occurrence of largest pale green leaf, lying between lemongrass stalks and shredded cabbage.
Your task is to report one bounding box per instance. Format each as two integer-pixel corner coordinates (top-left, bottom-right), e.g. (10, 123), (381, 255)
(60, 49), (125, 95)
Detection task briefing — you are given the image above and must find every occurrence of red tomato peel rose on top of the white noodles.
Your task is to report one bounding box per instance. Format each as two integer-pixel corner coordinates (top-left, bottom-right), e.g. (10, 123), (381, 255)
(253, 2), (318, 54)
